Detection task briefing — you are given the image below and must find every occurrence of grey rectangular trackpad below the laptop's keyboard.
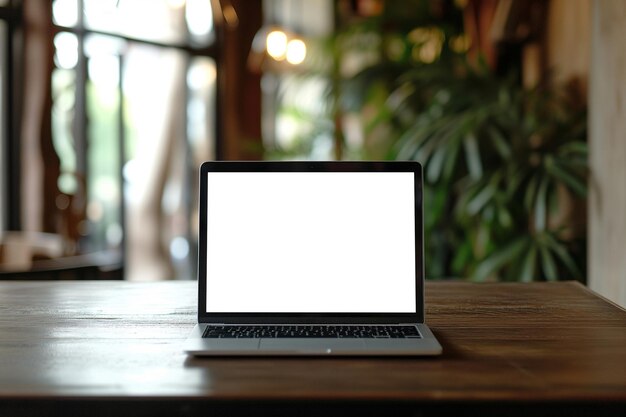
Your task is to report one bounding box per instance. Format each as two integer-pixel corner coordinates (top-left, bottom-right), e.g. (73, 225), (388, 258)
(259, 338), (365, 354)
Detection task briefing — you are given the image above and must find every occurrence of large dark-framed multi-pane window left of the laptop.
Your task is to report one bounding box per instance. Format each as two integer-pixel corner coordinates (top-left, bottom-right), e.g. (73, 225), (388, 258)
(52, 0), (217, 280)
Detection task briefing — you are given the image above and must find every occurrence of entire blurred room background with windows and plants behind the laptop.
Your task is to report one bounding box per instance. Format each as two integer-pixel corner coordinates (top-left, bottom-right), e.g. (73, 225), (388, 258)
(0, 0), (626, 304)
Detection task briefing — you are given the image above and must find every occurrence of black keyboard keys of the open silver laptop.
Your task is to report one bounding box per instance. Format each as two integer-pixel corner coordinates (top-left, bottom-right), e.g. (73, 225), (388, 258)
(202, 325), (421, 339)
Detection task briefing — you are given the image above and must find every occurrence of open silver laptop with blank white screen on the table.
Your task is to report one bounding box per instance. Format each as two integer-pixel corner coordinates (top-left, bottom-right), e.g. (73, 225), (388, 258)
(184, 161), (441, 356)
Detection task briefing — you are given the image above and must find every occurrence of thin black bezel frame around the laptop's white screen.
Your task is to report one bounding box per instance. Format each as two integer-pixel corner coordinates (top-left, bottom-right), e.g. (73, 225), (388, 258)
(198, 161), (424, 324)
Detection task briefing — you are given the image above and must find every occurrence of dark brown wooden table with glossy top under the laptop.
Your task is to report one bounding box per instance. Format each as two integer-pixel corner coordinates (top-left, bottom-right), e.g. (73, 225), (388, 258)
(0, 281), (626, 417)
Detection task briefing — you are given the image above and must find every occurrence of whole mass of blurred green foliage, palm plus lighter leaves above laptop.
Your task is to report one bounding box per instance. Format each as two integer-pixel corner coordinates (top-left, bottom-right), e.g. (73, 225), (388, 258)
(339, 1), (587, 281)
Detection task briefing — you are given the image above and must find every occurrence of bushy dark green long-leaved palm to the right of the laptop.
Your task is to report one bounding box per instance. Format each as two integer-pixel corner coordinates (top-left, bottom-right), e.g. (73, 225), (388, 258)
(389, 63), (587, 281)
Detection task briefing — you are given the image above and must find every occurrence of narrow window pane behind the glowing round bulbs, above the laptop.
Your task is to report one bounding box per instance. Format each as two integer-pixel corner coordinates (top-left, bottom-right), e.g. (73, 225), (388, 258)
(257, 0), (334, 159)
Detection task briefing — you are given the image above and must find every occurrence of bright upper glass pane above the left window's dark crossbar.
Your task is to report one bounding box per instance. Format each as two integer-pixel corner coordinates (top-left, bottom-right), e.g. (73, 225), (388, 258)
(84, 0), (213, 43)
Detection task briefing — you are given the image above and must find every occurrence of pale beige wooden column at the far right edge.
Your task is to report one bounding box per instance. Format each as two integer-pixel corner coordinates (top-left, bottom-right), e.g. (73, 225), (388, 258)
(588, 0), (626, 306)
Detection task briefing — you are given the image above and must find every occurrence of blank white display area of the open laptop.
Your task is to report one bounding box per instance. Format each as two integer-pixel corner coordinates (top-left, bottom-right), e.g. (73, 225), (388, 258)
(206, 172), (417, 313)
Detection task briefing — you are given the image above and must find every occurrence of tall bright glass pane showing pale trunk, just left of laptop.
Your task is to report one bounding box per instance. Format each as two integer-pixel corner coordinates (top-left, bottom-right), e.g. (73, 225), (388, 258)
(122, 44), (188, 280)
